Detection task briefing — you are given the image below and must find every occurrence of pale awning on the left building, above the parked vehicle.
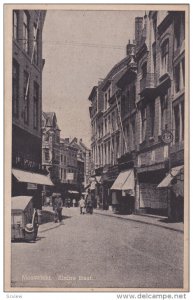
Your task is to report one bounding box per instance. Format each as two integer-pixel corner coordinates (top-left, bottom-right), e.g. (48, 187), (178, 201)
(12, 169), (53, 185)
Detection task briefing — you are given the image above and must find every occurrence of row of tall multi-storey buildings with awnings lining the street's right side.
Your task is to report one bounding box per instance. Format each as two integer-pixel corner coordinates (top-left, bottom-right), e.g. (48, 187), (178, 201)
(89, 11), (185, 220)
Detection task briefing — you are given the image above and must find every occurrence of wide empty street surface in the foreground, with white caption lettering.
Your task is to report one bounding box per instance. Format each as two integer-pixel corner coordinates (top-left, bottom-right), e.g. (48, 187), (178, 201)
(11, 208), (183, 288)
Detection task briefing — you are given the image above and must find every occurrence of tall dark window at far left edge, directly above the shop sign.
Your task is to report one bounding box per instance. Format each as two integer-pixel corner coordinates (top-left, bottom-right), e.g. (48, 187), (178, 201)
(12, 61), (19, 118)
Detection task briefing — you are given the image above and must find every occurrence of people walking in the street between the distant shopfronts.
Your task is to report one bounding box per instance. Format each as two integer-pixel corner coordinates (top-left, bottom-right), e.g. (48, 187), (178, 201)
(52, 191), (93, 223)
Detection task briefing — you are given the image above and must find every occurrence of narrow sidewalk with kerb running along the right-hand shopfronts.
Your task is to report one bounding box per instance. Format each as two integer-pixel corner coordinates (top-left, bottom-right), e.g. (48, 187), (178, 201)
(94, 209), (184, 233)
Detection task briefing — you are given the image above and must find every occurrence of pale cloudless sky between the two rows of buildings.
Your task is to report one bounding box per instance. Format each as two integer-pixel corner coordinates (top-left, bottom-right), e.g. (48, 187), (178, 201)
(42, 10), (145, 146)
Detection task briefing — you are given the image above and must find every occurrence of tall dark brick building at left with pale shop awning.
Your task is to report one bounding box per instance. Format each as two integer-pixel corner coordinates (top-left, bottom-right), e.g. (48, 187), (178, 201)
(12, 10), (52, 206)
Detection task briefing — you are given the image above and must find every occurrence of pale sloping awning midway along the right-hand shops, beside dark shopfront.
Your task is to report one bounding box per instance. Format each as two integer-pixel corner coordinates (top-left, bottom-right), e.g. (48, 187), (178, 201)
(111, 169), (135, 191)
